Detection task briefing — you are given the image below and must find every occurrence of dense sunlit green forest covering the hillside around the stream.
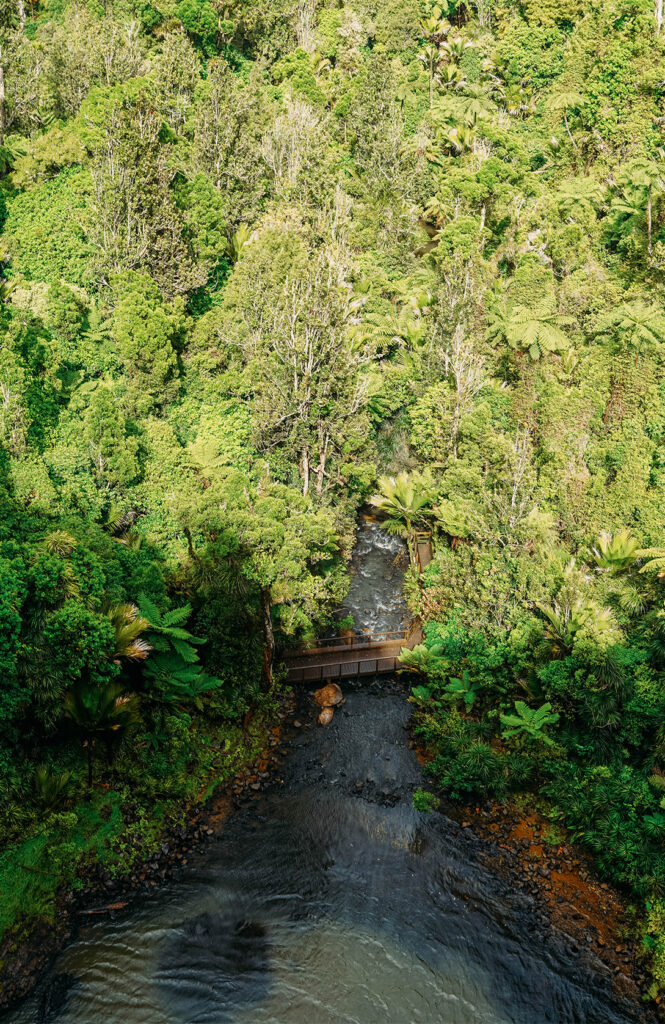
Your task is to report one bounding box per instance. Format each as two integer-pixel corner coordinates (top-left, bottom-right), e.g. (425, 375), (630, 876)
(0, 0), (665, 999)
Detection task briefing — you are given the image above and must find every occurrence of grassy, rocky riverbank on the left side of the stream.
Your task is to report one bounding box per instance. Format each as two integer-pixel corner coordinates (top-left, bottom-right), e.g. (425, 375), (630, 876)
(0, 695), (293, 1012)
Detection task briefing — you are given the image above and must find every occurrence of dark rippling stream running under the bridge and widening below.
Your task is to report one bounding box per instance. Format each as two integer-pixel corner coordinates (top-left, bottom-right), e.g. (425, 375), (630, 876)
(5, 521), (639, 1024)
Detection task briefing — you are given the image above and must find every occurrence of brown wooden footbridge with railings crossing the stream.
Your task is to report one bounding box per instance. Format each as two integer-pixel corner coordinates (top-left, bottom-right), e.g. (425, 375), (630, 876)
(284, 620), (422, 683)
